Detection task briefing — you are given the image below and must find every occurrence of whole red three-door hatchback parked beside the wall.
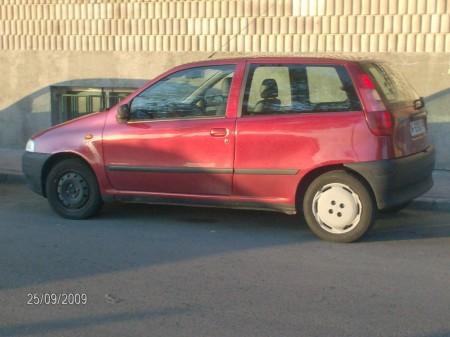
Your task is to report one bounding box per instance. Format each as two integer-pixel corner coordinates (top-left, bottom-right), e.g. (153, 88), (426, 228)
(23, 57), (434, 242)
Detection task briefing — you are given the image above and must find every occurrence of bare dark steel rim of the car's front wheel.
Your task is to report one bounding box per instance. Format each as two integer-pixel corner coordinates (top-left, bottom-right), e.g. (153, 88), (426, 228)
(57, 172), (89, 209)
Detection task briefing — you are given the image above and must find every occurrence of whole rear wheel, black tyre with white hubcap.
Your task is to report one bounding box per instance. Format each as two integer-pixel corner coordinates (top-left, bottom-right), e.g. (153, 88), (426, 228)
(303, 170), (376, 242)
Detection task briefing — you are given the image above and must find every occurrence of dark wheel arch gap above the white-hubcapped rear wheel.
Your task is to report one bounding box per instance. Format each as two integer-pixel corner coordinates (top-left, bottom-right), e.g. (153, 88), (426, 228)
(295, 164), (377, 212)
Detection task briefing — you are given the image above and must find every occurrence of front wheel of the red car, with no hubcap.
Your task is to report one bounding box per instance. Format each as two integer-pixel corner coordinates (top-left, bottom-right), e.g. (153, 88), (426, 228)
(45, 159), (103, 220)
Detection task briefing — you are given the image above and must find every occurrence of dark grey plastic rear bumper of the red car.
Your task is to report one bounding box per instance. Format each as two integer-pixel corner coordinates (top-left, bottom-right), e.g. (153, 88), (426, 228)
(345, 146), (435, 209)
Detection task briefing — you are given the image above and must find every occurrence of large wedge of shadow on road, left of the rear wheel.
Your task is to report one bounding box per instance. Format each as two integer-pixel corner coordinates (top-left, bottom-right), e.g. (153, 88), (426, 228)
(0, 182), (317, 291)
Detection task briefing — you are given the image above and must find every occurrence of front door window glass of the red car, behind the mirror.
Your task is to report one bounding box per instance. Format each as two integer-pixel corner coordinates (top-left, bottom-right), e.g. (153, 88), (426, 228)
(130, 65), (235, 120)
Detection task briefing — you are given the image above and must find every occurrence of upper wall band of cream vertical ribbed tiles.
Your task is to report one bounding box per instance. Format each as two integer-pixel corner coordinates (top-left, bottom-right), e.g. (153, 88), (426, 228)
(0, 0), (450, 53)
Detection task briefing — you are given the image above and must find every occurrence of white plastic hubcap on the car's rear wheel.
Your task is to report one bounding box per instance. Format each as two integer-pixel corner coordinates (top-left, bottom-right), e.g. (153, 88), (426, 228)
(312, 183), (362, 234)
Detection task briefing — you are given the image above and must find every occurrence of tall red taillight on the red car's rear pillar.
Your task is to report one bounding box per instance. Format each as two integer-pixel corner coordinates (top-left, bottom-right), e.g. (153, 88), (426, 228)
(359, 73), (394, 136)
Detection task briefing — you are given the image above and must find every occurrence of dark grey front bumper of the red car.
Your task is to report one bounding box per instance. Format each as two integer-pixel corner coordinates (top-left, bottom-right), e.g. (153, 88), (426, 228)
(22, 152), (50, 196)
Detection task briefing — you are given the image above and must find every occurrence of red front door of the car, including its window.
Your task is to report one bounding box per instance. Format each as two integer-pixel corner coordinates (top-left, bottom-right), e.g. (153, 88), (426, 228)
(103, 64), (243, 195)
